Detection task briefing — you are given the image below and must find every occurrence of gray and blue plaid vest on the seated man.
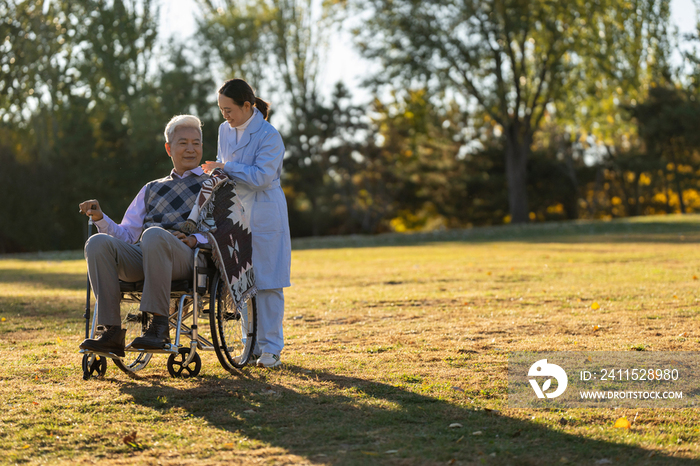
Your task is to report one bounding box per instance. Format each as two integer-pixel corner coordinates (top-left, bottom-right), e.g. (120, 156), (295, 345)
(143, 174), (209, 231)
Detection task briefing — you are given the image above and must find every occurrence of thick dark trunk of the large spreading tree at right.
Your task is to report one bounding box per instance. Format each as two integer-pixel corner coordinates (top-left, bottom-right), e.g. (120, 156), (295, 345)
(505, 124), (532, 223)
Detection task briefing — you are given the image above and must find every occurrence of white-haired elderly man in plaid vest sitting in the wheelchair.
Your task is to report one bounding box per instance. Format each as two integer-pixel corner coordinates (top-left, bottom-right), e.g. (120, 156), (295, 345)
(80, 115), (209, 356)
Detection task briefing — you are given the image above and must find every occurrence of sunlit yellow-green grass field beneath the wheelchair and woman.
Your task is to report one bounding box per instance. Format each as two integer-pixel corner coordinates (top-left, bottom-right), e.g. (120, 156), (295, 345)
(0, 216), (700, 465)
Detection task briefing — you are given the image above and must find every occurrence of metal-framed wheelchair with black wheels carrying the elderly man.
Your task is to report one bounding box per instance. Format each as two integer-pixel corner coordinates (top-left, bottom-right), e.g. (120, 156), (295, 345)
(80, 244), (257, 380)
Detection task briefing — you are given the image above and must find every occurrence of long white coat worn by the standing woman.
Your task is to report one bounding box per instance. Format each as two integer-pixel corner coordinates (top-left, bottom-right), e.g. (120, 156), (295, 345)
(216, 109), (292, 290)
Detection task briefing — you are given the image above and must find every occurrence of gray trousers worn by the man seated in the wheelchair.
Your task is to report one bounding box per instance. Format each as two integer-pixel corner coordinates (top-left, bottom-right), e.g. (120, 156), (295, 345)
(85, 227), (194, 325)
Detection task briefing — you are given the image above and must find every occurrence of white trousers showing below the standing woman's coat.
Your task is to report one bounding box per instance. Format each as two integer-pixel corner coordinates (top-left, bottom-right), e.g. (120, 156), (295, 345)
(253, 288), (284, 355)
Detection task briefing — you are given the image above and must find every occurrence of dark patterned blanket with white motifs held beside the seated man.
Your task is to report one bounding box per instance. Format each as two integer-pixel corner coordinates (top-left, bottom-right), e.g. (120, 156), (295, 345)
(181, 168), (257, 311)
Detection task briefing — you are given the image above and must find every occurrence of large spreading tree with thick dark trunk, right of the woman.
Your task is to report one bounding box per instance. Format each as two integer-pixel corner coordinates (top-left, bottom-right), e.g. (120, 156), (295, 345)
(354, 0), (680, 222)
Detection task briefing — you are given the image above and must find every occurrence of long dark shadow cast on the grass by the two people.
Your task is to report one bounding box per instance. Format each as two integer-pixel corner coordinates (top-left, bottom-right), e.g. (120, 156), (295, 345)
(120, 365), (697, 465)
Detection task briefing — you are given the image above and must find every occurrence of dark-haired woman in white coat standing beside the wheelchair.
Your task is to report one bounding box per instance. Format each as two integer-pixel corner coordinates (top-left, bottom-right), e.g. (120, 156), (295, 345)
(202, 79), (292, 367)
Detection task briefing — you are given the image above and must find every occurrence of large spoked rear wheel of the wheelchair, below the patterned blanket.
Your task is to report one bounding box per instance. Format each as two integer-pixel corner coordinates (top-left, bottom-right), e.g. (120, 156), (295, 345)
(209, 274), (258, 372)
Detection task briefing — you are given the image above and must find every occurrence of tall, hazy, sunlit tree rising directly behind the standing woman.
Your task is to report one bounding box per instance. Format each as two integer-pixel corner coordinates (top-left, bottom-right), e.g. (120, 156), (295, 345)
(199, 0), (355, 235)
